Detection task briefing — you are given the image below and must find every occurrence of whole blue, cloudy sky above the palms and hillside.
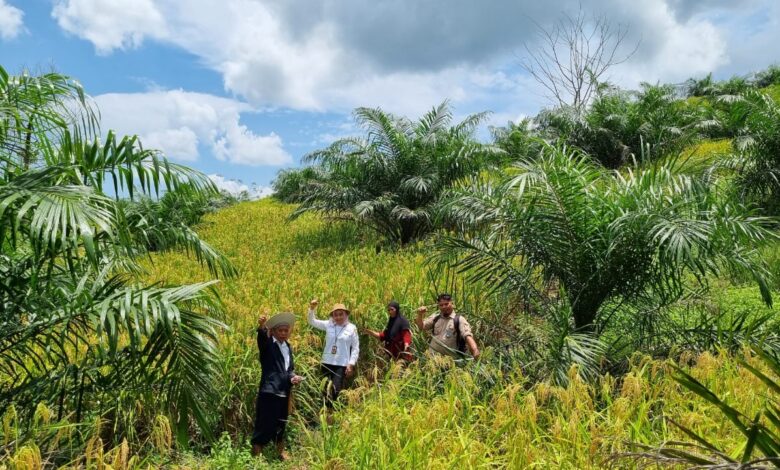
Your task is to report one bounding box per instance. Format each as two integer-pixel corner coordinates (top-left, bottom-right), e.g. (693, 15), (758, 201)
(0, 0), (780, 194)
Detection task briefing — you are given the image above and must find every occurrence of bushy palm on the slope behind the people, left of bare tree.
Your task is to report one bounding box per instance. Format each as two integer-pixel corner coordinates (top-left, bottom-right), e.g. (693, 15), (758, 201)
(295, 101), (502, 244)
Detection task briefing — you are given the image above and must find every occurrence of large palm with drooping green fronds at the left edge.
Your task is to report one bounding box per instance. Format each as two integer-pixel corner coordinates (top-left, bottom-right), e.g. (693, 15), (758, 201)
(0, 68), (234, 443)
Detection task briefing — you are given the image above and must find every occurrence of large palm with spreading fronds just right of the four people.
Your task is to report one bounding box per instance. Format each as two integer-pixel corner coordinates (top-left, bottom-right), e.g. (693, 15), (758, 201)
(438, 146), (774, 332)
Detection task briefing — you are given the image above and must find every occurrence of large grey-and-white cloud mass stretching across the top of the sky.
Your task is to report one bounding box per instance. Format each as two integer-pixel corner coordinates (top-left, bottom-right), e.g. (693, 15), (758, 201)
(53, 0), (770, 114)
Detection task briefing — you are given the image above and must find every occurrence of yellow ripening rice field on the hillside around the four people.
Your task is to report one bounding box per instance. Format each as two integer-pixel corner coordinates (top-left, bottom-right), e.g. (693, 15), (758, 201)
(142, 199), (766, 468)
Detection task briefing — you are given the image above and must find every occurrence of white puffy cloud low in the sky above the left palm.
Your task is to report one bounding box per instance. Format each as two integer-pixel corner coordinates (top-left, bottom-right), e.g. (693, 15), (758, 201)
(95, 90), (292, 166)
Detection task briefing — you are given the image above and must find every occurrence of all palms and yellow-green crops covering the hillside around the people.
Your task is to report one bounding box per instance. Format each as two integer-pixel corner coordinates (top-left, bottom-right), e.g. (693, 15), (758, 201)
(0, 63), (780, 470)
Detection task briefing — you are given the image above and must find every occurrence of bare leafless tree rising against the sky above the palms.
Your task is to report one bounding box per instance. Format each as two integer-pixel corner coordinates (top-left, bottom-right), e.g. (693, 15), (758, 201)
(521, 5), (639, 112)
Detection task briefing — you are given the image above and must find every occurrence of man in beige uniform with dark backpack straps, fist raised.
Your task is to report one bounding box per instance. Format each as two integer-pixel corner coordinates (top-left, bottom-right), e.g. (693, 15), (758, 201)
(415, 294), (479, 359)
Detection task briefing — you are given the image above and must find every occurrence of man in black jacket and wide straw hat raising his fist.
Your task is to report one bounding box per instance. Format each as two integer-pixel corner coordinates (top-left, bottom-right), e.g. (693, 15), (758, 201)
(252, 313), (303, 460)
